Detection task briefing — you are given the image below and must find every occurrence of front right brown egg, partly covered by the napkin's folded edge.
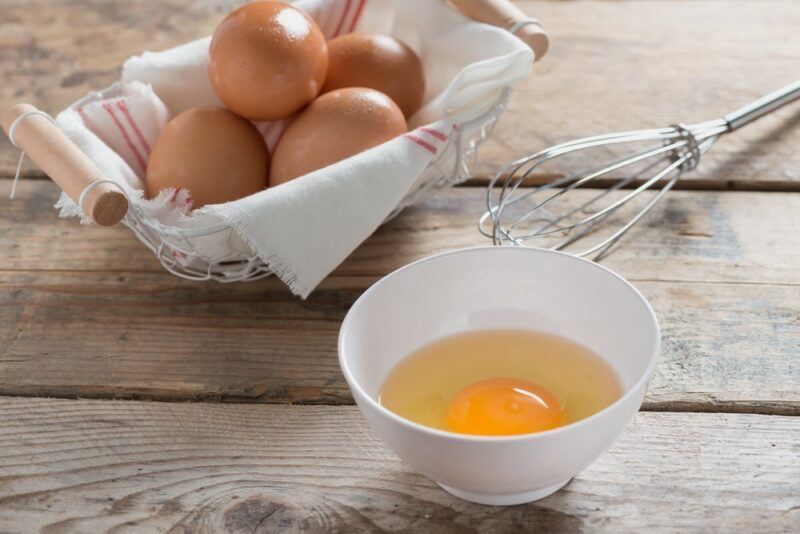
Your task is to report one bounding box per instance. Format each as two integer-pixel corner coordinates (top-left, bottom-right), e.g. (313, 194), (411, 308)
(270, 87), (407, 185)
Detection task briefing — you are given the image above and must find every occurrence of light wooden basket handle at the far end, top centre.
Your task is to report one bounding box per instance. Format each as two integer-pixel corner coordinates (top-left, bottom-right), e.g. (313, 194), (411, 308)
(450, 0), (550, 61)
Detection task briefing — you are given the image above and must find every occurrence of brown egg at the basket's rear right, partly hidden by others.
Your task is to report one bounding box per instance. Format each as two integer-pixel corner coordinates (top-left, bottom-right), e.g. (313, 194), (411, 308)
(322, 33), (425, 118)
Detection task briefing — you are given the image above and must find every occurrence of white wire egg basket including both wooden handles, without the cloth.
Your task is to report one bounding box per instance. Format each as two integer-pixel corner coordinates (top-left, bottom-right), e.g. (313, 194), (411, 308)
(4, 0), (546, 288)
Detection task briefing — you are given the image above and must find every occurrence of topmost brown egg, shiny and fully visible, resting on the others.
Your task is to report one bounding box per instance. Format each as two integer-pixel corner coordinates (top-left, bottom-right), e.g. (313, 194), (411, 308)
(209, 2), (328, 121)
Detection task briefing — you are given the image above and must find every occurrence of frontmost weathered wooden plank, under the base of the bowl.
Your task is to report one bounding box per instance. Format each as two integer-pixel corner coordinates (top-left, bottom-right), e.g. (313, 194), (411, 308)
(0, 399), (800, 532)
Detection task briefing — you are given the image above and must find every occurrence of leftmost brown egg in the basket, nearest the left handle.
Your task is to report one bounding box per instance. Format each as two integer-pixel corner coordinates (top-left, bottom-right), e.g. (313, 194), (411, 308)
(146, 107), (269, 208)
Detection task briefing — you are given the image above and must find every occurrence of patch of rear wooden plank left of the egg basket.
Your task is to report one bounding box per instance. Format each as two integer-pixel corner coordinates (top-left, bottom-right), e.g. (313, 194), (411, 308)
(0, 0), (230, 176)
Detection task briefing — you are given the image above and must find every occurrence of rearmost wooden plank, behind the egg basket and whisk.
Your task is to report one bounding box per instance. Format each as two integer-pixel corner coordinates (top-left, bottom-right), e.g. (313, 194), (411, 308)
(0, 0), (800, 190)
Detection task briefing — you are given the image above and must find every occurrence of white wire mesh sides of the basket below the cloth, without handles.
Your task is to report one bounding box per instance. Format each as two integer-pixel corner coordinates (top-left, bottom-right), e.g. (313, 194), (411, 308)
(122, 88), (511, 282)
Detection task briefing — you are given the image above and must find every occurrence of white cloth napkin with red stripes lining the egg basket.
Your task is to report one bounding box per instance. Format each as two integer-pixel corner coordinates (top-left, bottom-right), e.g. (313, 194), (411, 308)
(57, 0), (533, 298)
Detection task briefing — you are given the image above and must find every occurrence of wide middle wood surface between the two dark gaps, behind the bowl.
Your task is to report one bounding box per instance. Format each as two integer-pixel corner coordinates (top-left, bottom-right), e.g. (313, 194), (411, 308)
(0, 180), (800, 414)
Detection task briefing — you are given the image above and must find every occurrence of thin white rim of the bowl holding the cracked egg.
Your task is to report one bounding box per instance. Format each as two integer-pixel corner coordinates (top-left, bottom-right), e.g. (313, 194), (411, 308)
(337, 245), (661, 443)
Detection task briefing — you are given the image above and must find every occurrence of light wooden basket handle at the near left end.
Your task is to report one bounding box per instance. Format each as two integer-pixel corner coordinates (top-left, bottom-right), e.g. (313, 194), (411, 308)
(3, 104), (128, 226)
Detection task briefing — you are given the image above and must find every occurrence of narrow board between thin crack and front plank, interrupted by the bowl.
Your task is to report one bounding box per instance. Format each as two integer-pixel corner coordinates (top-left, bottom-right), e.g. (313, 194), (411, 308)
(0, 272), (800, 414)
